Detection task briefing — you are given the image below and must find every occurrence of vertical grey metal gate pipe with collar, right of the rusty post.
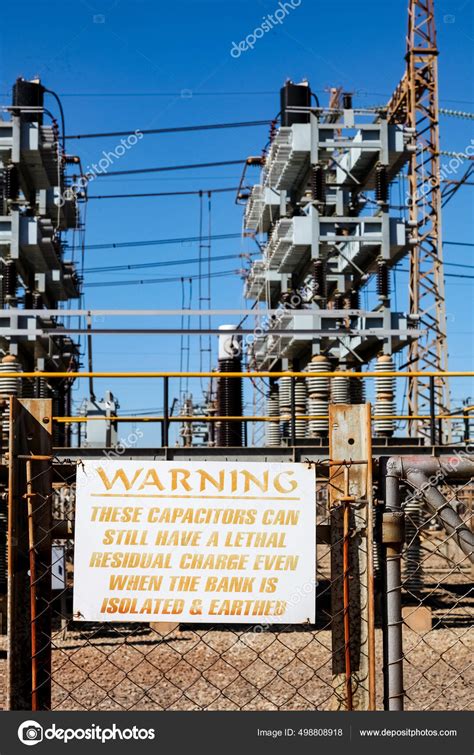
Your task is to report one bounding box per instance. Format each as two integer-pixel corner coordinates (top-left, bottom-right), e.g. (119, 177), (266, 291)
(384, 460), (404, 710)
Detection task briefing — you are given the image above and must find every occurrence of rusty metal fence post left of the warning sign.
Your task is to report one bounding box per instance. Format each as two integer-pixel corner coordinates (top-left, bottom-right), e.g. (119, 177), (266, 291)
(7, 398), (52, 710)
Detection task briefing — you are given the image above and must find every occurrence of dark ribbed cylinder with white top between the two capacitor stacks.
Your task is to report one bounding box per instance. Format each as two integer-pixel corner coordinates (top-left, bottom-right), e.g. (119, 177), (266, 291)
(216, 325), (243, 447)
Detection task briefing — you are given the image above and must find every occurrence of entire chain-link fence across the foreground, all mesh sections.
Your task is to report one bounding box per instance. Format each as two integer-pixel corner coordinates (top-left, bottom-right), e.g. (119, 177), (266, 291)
(0, 452), (474, 710)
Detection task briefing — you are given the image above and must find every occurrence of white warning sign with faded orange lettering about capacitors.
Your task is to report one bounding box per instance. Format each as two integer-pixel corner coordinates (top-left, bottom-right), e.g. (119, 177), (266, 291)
(74, 459), (316, 624)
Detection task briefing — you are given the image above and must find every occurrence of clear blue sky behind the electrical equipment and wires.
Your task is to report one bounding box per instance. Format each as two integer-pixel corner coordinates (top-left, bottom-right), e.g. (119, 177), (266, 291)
(0, 0), (474, 444)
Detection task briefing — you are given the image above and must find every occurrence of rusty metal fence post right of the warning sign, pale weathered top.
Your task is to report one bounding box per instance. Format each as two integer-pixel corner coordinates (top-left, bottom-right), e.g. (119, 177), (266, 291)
(329, 404), (374, 710)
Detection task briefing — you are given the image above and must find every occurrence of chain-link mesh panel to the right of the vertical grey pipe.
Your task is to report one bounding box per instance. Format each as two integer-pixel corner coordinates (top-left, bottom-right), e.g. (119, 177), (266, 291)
(402, 479), (474, 710)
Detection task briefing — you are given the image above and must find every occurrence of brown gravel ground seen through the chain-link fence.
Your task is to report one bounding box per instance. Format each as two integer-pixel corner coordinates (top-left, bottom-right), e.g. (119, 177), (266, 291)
(0, 627), (474, 710)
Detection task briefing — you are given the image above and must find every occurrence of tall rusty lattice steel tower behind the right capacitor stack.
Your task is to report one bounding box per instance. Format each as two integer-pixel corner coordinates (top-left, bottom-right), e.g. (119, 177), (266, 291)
(388, 0), (450, 442)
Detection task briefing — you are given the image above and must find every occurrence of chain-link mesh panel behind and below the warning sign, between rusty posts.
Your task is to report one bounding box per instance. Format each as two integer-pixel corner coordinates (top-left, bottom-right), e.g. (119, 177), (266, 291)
(19, 464), (348, 710)
